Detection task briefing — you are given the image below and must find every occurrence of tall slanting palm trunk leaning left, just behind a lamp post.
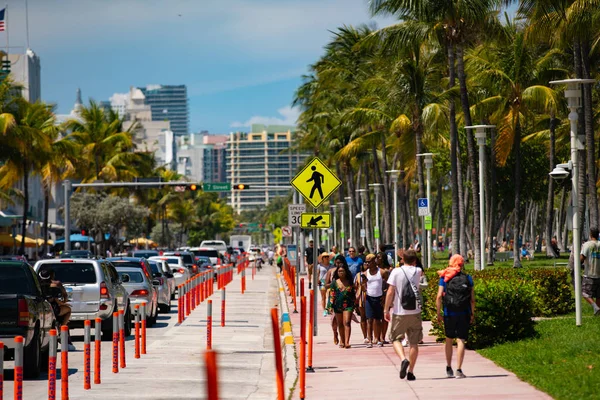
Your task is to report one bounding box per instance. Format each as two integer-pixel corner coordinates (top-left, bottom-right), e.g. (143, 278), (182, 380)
(456, 43), (483, 269)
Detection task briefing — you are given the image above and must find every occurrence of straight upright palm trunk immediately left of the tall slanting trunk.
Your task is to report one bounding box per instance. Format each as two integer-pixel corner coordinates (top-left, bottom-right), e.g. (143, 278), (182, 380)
(446, 44), (462, 254)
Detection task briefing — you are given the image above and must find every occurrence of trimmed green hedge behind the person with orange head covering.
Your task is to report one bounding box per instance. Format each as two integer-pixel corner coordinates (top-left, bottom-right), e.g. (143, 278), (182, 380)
(423, 268), (575, 348)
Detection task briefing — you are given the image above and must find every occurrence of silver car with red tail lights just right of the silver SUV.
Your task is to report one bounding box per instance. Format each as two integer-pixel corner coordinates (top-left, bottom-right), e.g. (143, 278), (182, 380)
(116, 266), (158, 327)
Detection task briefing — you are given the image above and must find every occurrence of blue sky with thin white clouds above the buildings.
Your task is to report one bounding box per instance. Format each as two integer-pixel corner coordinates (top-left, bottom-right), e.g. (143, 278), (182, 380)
(9, 0), (392, 133)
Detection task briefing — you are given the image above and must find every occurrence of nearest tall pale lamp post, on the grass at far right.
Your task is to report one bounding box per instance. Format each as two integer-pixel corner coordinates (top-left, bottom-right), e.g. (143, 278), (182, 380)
(550, 79), (595, 326)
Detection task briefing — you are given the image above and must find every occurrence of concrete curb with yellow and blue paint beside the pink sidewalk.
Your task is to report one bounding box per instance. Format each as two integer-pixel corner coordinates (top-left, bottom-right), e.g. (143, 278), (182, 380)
(277, 274), (298, 399)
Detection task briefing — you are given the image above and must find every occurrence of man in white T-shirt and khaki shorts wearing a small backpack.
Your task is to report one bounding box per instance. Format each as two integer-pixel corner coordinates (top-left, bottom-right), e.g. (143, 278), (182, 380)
(384, 250), (423, 381)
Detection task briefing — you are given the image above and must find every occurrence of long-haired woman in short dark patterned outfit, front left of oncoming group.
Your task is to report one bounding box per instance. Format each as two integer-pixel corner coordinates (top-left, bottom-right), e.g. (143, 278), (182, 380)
(329, 255), (356, 349)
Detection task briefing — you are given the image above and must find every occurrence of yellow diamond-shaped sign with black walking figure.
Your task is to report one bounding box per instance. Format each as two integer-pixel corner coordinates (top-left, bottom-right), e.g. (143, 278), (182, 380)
(290, 157), (342, 208)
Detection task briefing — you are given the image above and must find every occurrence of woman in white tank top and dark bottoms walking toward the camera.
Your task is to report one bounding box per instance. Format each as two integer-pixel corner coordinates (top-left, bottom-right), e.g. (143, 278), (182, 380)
(364, 254), (383, 347)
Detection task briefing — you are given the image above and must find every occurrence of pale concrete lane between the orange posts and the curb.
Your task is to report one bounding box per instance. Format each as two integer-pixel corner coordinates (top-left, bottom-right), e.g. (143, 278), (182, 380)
(4, 266), (278, 400)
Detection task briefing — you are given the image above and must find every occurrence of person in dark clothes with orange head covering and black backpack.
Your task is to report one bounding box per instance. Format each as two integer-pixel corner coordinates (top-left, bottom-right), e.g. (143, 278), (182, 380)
(435, 254), (475, 379)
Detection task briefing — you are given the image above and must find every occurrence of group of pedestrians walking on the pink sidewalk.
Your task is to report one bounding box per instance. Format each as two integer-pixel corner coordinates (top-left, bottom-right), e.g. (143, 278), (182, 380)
(312, 243), (475, 380)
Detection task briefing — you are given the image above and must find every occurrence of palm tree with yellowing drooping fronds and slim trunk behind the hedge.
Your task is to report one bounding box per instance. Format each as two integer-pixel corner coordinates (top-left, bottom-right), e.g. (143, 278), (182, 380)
(466, 22), (558, 267)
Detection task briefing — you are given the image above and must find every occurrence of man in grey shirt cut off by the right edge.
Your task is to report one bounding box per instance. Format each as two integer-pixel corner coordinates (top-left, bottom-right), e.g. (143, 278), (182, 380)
(581, 228), (600, 316)
